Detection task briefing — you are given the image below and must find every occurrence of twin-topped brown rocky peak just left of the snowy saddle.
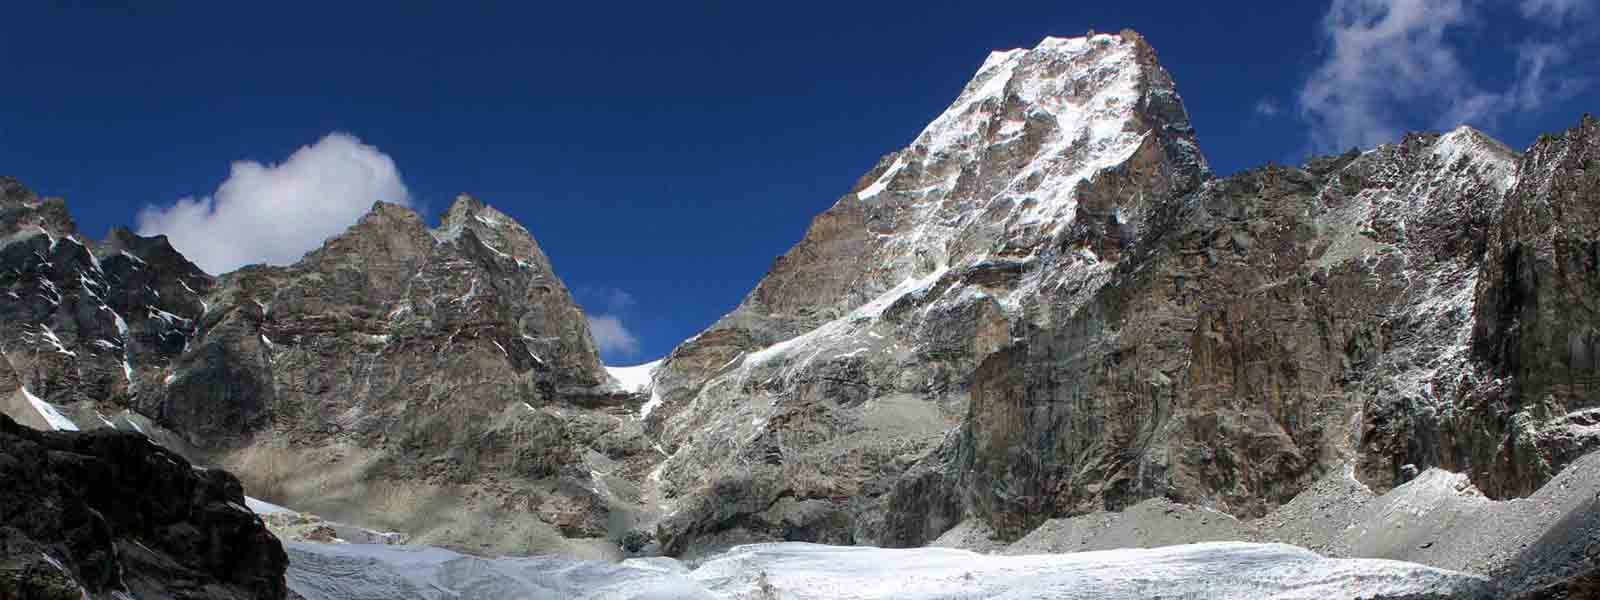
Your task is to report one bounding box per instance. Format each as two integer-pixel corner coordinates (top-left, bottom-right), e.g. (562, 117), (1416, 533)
(141, 197), (648, 554)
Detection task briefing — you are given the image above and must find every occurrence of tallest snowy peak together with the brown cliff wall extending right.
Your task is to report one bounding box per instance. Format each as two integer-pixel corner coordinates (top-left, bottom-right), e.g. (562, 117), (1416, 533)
(636, 32), (1597, 554)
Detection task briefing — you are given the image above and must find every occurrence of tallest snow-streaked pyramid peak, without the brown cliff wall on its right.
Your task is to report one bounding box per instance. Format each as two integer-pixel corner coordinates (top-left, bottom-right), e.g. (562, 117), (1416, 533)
(636, 32), (1208, 550)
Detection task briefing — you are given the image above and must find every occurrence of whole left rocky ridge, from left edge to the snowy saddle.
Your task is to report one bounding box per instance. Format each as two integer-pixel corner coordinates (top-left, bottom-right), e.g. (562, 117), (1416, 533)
(0, 179), (654, 554)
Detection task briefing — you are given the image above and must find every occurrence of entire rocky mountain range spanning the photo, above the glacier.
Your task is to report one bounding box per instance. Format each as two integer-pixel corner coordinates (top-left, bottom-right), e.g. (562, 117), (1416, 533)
(0, 32), (1600, 594)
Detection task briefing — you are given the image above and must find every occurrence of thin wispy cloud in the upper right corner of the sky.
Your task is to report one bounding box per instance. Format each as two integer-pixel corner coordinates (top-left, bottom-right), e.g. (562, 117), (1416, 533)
(1298, 0), (1587, 152)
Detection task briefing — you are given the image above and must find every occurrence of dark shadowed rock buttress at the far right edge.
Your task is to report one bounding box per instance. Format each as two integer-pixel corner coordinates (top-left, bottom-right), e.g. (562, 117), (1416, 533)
(1458, 117), (1600, 498)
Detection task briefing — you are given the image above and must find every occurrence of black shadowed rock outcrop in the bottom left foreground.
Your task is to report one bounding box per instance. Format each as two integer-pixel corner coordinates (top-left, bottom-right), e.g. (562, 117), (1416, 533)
(0, 414), (288, 600)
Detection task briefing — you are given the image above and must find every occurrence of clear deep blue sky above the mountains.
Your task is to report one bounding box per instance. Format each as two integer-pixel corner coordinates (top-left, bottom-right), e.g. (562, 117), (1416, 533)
(0, 2), (1600, 363)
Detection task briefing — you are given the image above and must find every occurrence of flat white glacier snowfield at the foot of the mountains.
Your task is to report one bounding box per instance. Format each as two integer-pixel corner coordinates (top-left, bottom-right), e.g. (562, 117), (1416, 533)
(285, 542), (1491, 600)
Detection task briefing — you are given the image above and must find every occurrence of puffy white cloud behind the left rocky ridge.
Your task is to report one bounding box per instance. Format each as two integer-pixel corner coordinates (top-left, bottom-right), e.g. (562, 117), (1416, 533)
(138, 133), (411, 274)
